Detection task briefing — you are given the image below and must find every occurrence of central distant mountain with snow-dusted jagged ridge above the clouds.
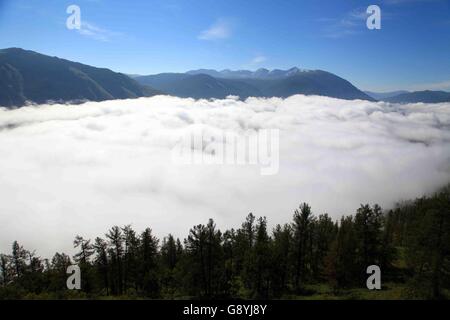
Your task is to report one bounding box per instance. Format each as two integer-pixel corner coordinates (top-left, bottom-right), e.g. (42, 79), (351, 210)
(134, 68), (375, 101)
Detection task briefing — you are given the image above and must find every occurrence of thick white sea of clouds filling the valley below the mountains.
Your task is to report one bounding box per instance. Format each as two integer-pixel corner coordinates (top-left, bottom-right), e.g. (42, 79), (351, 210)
(0, 95), (450, 257)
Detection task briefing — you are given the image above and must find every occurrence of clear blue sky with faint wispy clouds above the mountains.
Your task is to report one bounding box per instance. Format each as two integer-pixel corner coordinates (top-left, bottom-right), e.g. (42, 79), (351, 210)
(0, 0), (450, 91)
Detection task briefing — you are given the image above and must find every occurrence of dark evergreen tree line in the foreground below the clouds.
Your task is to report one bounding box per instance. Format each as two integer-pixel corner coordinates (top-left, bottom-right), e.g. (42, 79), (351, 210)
(0, 186), (450, 299)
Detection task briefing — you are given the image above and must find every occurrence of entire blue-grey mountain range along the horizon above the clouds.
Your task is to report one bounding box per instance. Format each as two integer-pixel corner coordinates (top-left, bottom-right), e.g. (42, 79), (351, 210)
(0, 48), (450, 108)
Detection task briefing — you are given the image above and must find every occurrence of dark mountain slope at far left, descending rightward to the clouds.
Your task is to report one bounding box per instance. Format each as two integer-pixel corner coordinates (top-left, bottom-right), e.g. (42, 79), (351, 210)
(0, 48), (159, 107)
